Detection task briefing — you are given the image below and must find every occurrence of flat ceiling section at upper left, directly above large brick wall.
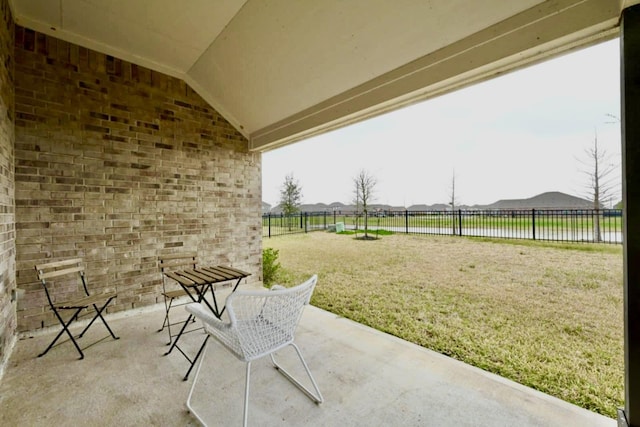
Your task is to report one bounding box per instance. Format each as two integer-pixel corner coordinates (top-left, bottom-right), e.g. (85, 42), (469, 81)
(10, 0), (246, 78)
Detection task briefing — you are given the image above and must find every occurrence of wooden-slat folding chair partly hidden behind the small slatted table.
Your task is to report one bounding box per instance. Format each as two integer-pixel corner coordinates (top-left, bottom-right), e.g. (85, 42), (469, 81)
(158, 252), (198, 345)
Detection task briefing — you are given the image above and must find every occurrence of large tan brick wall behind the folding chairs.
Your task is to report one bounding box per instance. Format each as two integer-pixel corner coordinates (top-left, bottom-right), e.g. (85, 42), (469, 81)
(15, 26), (262, 331)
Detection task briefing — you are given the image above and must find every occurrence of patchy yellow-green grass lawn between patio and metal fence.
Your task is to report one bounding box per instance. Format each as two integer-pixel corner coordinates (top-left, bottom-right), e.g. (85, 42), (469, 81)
(263, 232), (624, 418)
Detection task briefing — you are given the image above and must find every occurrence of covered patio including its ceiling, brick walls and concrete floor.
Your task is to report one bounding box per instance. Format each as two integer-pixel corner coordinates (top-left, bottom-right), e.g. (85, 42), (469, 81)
(0, 0), (640, 426)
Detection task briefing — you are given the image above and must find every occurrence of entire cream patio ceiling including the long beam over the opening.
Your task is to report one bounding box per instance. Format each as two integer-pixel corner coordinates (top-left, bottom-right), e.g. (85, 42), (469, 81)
(10, 0), (640, 151)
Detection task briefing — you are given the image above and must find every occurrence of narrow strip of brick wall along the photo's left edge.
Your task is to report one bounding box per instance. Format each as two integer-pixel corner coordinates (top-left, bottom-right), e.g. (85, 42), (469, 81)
(0, 0), (16, 376)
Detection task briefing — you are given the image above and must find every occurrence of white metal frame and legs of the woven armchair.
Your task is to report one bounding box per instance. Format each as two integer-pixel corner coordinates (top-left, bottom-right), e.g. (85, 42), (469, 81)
(186, 275), (324, 427)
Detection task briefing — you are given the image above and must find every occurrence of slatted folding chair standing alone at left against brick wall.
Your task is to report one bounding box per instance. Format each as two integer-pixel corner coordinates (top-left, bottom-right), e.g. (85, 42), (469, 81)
(35, 258), (120, 359)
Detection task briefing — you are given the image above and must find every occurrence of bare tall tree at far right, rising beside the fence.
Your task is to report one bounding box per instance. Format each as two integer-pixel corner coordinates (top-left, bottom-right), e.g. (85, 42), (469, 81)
(581, 132), (618, 242)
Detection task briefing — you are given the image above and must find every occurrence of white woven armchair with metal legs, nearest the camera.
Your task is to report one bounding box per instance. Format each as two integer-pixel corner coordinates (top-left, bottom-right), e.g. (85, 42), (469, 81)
(186, 275), (323, 426)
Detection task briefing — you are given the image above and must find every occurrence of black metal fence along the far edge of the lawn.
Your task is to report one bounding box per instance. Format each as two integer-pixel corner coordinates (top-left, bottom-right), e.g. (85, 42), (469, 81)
(262, 209), (622, 244)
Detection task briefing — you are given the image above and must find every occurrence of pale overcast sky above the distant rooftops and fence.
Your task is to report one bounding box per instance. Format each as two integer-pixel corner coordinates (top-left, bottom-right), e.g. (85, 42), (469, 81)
(262, 39), (620, 207)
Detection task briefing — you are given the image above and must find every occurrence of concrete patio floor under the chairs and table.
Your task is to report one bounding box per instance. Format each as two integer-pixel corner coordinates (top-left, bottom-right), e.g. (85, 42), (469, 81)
(0, 298), (616, 427)
